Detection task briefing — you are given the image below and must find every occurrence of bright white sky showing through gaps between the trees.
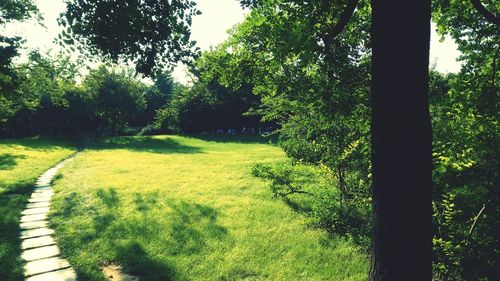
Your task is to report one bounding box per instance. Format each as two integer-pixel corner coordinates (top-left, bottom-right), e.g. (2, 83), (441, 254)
(1, 0), (460, 84)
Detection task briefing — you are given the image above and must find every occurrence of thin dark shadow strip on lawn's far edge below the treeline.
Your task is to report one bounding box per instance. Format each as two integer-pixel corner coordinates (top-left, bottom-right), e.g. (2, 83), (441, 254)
(88, 136), (202, 154)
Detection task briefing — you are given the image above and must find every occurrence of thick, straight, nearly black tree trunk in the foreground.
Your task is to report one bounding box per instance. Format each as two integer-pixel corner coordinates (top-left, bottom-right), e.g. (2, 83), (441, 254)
(370, 0), (432, 281)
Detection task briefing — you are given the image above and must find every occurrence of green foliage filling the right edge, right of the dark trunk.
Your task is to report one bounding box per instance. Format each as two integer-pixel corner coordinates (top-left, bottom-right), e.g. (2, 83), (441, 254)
(431, 0), (500, 280)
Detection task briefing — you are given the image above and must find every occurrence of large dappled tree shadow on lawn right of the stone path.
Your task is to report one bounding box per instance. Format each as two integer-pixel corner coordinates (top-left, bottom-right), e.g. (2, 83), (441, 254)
(60, 188), (228, 281)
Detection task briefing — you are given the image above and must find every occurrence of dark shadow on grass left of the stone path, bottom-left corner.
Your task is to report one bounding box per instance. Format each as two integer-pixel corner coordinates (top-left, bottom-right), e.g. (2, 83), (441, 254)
(0, 194), (29, 280)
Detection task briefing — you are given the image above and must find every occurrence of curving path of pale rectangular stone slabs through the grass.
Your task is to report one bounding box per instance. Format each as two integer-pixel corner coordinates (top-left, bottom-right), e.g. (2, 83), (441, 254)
(19, 157), (77, 281)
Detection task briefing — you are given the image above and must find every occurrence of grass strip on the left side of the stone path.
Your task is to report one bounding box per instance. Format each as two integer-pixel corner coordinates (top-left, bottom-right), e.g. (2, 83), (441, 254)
(0, 138), (75, 281)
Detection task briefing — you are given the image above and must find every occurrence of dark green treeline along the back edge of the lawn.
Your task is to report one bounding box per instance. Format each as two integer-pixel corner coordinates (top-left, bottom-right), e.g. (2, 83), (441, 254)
(0, 52), (262, 137)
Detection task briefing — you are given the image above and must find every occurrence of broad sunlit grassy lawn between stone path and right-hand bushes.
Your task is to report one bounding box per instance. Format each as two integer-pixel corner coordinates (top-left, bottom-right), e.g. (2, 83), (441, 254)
(50, 136), (368, 281)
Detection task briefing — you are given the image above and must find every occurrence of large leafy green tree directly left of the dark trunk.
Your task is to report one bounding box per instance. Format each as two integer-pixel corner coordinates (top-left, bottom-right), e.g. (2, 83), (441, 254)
(218, 1), (370, 238)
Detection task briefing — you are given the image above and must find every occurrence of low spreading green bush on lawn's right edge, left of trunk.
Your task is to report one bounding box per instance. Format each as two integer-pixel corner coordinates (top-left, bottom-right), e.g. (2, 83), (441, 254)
(252, 164), (371, 248)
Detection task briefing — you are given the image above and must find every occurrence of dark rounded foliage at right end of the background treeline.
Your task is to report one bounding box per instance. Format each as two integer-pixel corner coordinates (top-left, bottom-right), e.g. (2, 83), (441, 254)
(158, 46), (262, 133)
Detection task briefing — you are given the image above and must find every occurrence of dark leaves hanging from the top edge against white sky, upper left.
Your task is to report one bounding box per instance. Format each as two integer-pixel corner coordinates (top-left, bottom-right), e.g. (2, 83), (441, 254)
(59, 0), (199, 76)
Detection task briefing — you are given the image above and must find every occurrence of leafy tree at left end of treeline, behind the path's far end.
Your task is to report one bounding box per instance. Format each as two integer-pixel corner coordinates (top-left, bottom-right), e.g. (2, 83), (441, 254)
(2, 51), (83, 135)
